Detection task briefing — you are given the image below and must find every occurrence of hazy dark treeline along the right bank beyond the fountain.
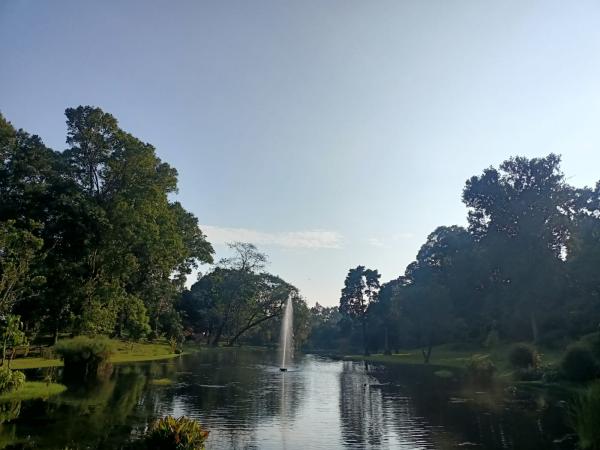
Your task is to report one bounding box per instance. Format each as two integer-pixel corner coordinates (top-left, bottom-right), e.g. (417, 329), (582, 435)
(308, 154), (600, 361)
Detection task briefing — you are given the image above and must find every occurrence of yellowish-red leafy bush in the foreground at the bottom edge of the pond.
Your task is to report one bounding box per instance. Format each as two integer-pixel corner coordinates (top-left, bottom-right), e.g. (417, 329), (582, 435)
(140, 416), (208, 450)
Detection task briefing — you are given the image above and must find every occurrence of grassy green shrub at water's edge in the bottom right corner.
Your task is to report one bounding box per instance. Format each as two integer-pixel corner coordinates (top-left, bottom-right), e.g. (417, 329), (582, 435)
(570, 382), (600, 450)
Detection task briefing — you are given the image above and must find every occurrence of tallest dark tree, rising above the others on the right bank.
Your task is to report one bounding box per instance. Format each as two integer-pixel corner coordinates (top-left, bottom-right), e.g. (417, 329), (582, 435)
(463, 154), (572, 342)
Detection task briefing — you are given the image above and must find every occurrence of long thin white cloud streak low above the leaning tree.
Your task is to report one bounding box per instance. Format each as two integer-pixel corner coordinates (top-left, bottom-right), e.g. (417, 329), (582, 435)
(200, 225), (342, 249)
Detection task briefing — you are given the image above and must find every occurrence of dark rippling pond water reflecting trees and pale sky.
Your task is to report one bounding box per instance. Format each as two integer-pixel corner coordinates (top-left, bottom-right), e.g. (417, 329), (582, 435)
(0, 350), (574, 450)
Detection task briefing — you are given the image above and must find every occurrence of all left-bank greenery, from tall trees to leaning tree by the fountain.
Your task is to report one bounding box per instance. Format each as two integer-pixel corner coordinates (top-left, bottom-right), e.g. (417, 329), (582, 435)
(0, 106), (308, 394)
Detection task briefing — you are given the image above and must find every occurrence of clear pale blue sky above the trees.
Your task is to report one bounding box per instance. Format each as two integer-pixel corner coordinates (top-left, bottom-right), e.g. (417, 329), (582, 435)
(0, 0), (600, 305)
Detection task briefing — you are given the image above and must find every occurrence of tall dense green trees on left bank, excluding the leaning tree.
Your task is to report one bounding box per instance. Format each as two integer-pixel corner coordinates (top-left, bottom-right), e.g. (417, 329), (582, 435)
(0, 106), (213, 339)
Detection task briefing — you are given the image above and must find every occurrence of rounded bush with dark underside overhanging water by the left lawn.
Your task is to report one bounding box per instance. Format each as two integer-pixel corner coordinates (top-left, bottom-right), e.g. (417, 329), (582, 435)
(54, 336), (112, 380)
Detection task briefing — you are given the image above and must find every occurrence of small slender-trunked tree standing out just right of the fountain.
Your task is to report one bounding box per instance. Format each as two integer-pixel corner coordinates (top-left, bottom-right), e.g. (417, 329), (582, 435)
(340, 266), (380, 355)
